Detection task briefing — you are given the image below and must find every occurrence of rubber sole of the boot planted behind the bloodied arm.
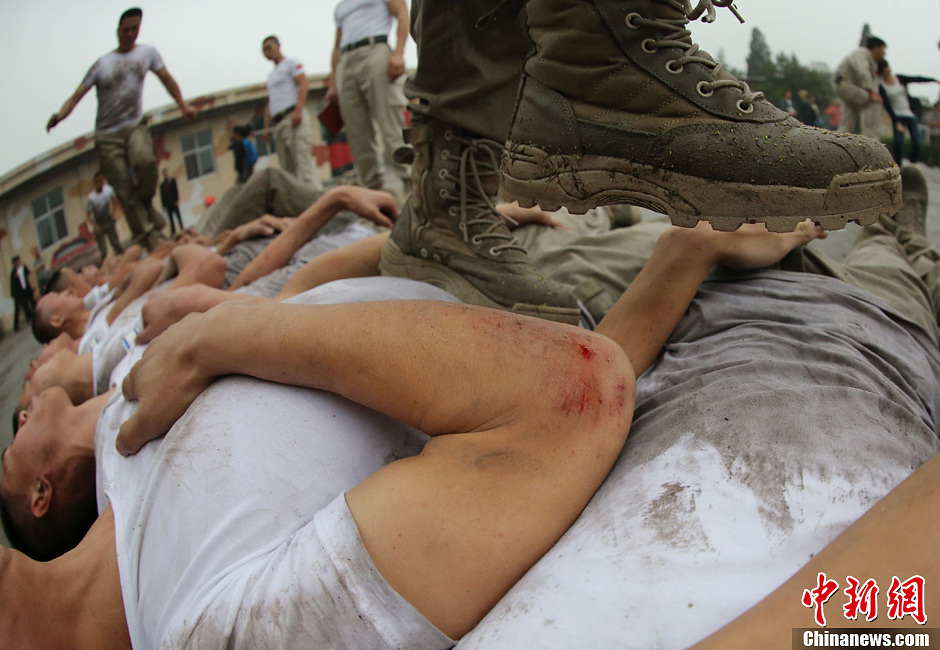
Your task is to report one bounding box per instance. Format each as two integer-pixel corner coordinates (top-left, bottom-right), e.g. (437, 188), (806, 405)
(379, 239), (581, 325)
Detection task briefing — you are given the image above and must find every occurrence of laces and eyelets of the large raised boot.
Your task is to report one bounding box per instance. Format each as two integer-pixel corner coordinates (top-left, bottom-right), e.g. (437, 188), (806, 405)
(626, 0), (764, 113)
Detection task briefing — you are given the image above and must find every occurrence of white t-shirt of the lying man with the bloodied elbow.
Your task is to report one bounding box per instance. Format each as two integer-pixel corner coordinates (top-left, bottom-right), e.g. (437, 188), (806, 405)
(96, 278), (454, 650)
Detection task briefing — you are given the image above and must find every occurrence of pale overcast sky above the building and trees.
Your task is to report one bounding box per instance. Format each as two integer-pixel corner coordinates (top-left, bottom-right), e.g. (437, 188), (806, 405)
(0, 0), (940, 175)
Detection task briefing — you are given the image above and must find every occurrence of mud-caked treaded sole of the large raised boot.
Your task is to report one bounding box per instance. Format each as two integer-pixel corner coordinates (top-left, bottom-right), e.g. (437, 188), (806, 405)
(500, 142), (902, 232)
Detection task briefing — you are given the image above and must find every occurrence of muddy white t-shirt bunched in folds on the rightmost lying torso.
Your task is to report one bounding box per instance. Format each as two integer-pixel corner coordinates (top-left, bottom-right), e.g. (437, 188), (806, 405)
(457, 271), (940, 650)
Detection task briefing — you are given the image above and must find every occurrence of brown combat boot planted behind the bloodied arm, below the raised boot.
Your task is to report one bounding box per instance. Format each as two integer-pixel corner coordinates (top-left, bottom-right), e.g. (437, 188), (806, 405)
(379, 119), (580, 324)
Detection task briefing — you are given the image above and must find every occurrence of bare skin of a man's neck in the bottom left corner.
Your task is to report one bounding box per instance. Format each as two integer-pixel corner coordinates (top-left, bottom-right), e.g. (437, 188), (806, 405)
(0, 509), (130, 650)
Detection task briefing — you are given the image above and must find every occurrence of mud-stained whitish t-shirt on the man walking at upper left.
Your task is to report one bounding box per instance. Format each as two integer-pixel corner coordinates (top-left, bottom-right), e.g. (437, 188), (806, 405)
(82, 44), (164, 133)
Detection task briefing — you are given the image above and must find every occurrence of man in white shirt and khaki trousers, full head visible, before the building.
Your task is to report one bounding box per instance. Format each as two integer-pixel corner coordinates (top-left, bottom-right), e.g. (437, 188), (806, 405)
(261, 35), (323, 190)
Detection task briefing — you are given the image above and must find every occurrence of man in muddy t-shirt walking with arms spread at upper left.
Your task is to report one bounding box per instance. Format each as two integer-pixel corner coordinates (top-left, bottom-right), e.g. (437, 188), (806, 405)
(46, 7), (196, 251)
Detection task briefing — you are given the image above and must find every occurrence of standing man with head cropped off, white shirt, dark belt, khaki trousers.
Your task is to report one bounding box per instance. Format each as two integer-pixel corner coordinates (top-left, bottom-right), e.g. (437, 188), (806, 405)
(327, 0), (410, 199)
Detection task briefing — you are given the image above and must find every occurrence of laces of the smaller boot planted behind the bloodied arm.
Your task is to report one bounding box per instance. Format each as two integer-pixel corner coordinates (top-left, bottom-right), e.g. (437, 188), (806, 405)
(439, 130), (525, 257)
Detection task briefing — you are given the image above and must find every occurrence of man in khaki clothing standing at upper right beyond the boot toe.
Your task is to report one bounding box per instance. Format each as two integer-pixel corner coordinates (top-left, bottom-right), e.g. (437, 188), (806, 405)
(835, 36), (888, 138)
